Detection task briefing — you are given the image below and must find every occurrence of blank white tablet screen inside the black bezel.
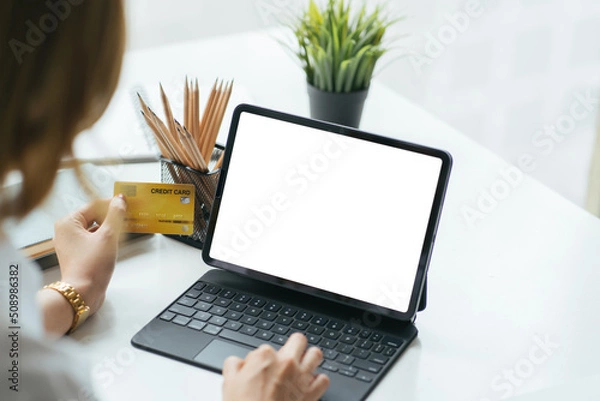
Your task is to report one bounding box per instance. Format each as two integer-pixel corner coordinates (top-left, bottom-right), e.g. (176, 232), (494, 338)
(209, 112), (442, 312)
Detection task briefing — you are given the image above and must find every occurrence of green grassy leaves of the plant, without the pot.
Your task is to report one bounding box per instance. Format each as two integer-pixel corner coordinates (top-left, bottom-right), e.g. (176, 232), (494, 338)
(291, 0), (398, 92)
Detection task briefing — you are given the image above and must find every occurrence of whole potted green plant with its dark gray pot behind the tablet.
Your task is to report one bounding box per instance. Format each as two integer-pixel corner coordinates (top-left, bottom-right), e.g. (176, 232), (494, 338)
(291, 0), (397, 127)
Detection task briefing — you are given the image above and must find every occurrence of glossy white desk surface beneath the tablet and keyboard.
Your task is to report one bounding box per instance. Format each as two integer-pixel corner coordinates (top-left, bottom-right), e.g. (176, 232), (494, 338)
(45, 28), (600, 401)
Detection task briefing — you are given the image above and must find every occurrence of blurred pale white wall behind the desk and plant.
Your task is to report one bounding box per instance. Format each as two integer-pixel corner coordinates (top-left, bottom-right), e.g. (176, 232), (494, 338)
(127, 0), (600, 206)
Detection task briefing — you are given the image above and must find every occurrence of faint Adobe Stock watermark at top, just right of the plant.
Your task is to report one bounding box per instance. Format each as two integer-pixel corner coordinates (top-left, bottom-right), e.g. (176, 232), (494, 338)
(407, 0), (485, 76)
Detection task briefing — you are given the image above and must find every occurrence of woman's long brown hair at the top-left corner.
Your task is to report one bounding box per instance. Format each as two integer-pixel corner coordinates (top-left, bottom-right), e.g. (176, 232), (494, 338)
(0, 0), (125, 221)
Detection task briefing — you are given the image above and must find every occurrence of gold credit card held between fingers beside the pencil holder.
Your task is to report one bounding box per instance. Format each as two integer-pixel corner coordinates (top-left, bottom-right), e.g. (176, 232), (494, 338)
(115, 181), (195, 235)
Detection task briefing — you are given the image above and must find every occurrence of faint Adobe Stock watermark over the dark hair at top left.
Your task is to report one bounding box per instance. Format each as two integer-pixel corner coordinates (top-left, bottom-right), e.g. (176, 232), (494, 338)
(8, 0), (85, 64)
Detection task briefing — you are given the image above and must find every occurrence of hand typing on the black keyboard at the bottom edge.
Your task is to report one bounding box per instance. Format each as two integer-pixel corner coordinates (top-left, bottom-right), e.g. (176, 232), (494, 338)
(223, 333), (329, 401)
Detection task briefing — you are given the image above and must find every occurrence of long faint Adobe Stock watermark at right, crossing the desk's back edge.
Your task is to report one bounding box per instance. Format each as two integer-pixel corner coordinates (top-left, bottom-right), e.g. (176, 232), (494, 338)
(461, 89), (599, 227)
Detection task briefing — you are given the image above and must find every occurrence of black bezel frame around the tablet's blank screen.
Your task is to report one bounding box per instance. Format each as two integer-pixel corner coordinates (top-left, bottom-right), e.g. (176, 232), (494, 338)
(202, 104), (452, 321)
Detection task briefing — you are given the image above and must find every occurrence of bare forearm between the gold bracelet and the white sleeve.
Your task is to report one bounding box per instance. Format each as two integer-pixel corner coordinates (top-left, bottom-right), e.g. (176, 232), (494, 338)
(37, 289), (75, 337)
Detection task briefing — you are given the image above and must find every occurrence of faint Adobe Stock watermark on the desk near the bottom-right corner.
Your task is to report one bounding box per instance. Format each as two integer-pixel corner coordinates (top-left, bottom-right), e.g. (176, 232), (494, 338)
(479, 334), (560, 401)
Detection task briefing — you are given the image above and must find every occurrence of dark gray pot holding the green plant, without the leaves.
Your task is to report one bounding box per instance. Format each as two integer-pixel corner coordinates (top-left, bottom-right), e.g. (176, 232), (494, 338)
(307, 84), (369, 128)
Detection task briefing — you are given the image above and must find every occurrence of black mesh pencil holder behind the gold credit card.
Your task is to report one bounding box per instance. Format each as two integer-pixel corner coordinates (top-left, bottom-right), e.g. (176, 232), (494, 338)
(160, 145), (224, 249)
